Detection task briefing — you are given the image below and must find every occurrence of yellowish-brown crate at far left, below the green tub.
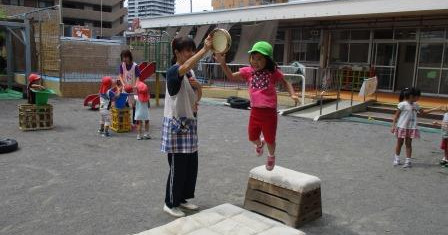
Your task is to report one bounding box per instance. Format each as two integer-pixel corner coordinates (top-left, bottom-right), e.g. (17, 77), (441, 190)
(18, 104), (53, 131)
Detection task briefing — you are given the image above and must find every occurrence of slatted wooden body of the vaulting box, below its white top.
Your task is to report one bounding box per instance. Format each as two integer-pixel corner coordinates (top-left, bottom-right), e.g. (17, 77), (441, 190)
(244, 170), (322, 228)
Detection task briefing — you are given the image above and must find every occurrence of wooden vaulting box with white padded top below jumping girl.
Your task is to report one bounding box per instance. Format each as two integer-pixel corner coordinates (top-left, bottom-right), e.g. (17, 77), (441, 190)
(244, 166), (322, 228)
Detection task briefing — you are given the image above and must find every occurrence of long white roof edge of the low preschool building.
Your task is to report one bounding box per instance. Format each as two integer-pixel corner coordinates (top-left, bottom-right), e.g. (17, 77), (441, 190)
(141, 0), (448, 28)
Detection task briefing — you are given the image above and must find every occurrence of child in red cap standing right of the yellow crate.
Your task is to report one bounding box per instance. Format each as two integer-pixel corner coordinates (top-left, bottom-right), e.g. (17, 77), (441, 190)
(134, 80), (151, 140)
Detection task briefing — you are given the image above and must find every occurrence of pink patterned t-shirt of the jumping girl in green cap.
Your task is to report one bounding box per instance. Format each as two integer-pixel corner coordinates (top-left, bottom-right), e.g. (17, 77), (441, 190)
(240, 67), (283, 109)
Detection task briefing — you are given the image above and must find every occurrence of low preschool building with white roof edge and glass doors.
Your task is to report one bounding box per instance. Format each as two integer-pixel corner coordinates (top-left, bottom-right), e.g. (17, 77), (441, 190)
(141, 0), (448, 97)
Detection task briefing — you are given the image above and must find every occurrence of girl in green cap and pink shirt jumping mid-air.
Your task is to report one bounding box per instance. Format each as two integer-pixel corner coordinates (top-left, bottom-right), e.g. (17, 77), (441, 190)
(215, 41), (299, 171)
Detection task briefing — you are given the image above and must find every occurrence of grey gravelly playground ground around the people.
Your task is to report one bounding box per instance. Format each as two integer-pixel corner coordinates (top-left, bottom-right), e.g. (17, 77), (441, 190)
(0, 99), (448, 235)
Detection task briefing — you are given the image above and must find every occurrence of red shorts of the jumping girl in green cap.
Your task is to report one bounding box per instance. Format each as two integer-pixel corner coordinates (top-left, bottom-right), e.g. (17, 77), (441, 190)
(248, 108), (277, 144)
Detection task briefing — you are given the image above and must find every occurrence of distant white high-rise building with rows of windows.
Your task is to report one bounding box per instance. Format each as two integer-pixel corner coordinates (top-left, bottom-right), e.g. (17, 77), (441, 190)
(128, 0), (174, 23)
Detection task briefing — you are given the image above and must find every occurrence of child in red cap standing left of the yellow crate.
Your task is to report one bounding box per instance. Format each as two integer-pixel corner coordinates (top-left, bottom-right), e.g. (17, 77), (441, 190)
(98, 77), (119, 137)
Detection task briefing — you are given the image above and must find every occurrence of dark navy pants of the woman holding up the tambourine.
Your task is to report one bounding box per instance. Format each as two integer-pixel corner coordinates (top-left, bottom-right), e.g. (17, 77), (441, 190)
(165, 152), (198, 208)
